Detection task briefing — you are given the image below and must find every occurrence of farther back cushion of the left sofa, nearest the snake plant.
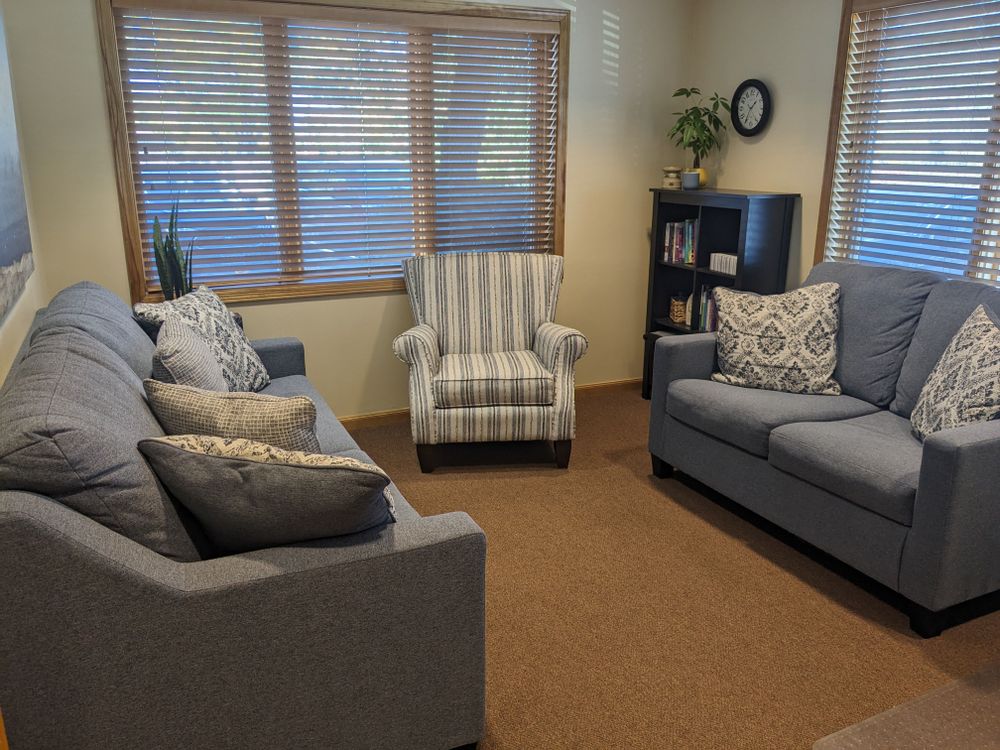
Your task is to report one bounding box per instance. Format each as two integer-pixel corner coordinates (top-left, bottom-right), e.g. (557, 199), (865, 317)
(36, 281), (156, 380)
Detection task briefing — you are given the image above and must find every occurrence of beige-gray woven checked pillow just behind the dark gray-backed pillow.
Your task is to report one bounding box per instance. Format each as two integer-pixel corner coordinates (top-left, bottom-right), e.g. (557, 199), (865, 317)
(142, 380), (320, 453)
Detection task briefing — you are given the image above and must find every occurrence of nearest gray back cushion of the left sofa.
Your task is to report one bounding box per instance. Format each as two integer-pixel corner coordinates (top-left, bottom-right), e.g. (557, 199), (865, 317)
(0, 326), (201, 561)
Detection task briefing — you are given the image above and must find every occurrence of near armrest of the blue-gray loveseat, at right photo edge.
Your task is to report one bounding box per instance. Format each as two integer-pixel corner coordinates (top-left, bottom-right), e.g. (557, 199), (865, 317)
(899, 421), (1000, 611)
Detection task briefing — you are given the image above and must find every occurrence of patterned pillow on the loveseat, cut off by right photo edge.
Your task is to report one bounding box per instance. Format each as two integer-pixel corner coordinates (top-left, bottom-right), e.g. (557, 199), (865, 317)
(910, 305), (1000, 440)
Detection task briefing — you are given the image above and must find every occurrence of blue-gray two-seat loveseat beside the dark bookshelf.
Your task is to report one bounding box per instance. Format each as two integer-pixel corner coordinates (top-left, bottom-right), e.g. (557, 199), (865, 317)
(649, 263), (1000, 637)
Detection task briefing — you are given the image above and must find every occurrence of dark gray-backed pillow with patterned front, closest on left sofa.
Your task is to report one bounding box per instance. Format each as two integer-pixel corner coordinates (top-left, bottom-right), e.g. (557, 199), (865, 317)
(139, 435), (395, 553)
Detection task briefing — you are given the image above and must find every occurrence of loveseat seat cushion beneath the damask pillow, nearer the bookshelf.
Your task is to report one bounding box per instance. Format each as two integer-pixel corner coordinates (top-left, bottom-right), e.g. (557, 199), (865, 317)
(667, 380), (878, 458)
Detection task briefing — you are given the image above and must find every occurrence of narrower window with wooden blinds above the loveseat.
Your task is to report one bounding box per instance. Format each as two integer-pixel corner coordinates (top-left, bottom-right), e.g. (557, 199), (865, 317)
(817, 0), (1000, 283)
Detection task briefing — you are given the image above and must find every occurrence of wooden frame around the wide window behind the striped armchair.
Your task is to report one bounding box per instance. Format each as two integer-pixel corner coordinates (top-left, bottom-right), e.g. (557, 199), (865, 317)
(95, 0), (571, 302)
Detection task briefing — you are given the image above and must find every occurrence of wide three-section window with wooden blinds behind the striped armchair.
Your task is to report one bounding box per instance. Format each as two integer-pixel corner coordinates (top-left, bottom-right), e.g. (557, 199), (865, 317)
(99, 0), (568, 300)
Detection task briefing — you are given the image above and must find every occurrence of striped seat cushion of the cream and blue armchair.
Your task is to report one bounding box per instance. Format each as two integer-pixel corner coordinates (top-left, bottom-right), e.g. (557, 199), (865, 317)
(431, 351), (556, 409)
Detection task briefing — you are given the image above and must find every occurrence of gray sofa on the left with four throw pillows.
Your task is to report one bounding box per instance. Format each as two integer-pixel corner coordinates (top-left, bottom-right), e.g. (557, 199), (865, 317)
(0, 284), (485, 750)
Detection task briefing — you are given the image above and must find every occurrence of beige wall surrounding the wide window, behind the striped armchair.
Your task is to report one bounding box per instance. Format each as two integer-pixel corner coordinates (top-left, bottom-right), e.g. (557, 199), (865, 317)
(0, 0), (685, 415)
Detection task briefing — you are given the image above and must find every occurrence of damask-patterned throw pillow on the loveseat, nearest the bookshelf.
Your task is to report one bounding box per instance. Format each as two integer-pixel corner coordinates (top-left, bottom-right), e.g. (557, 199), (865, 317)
(712, 283), (840, 396)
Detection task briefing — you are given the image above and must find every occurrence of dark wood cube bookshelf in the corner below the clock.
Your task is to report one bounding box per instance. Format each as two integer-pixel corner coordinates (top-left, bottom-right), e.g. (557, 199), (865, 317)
(642, 188), (799, 398)
